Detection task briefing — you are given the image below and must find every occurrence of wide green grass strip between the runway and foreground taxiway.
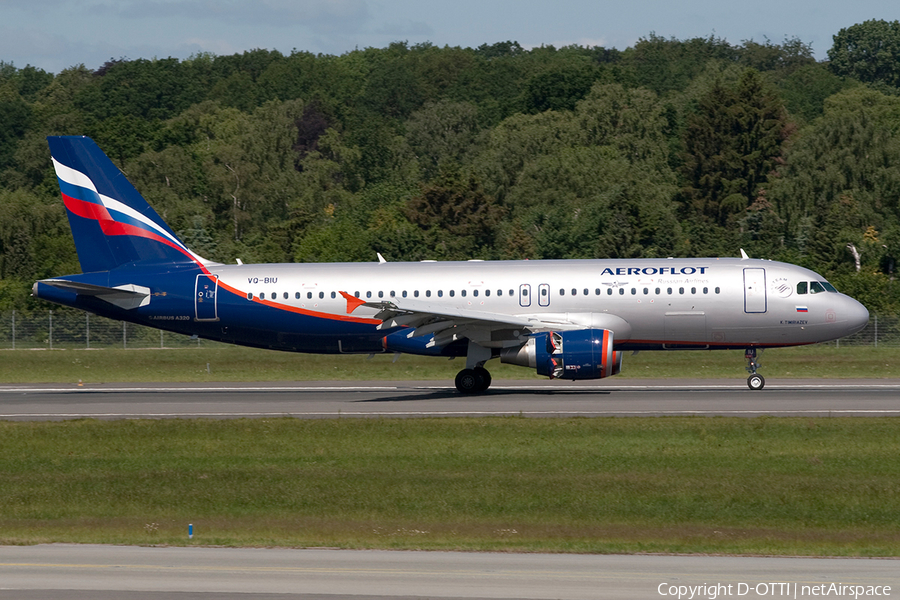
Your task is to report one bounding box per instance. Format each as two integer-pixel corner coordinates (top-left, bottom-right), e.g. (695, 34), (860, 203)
(0, 418), (900, 556)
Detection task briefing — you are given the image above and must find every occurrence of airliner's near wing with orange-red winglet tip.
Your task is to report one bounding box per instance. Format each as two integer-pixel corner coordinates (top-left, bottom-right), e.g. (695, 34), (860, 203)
(341, 292), (612, 348)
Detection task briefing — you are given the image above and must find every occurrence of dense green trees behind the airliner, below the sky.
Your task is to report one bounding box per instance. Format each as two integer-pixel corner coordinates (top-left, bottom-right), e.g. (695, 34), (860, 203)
(0, 21), (900, 312)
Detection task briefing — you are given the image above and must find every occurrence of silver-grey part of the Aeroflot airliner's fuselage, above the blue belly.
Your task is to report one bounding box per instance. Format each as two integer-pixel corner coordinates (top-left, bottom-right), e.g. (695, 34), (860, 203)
(210, 258), (868, 349)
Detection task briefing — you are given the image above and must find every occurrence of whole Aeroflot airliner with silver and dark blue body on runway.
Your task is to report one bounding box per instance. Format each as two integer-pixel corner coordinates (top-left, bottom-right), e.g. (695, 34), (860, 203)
(33, 137), (869, 394)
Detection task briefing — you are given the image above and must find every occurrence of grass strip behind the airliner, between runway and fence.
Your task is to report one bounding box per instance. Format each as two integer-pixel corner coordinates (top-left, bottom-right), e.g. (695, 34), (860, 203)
(0, 344), (900, 384)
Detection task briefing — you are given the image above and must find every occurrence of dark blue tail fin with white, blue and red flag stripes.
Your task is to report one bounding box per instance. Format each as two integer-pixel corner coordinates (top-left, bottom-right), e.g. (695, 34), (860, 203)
(47, 136), (207, 273)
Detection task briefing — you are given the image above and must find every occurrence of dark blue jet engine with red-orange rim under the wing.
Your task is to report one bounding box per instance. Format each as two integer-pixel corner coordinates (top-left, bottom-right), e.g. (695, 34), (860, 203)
(500, 329), (622, 379)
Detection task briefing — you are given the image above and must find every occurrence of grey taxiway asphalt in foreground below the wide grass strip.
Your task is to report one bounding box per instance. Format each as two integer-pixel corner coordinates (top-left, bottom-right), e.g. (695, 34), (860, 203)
(0, 544), (900, 600)
